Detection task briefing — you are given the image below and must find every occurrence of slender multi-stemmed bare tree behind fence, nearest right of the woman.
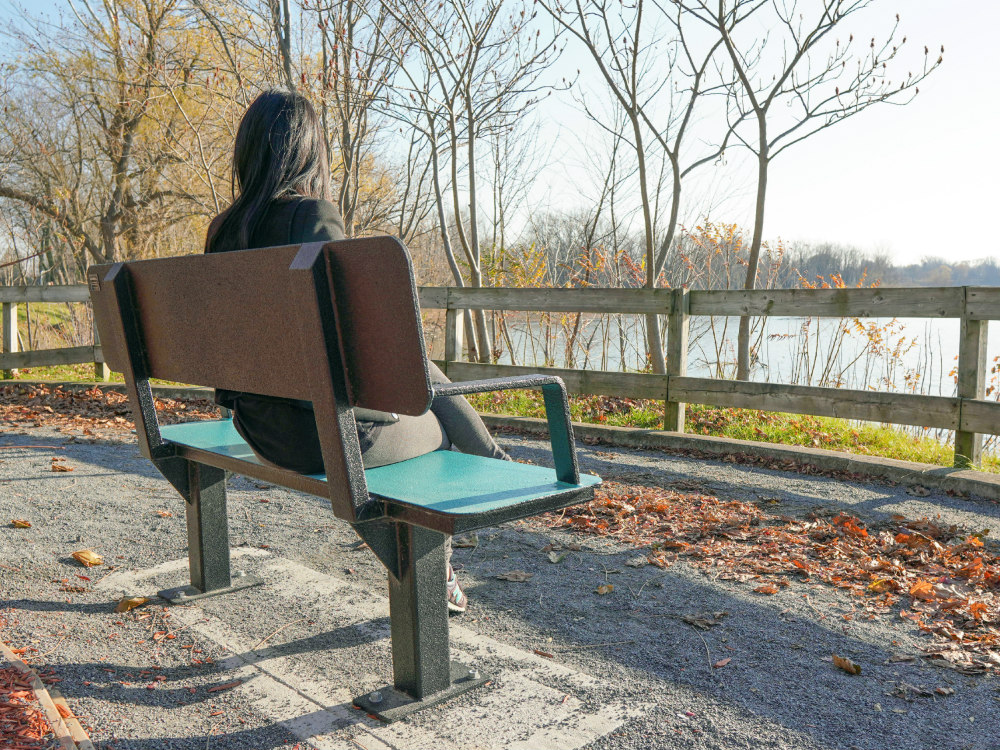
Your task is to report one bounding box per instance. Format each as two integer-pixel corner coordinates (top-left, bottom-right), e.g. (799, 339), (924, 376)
(386, 0), (558, 362)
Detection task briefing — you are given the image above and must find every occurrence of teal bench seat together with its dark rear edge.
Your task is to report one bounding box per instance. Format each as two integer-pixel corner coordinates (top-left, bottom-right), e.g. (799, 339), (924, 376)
(160, 419), (601, 533)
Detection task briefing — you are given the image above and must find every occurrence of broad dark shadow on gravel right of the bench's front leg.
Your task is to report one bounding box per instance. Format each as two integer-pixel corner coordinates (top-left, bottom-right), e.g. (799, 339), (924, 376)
(455, 531), (998, 750)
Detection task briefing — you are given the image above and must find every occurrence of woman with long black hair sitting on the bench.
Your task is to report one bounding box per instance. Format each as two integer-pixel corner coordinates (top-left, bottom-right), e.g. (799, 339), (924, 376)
(205, 90), (510, 612)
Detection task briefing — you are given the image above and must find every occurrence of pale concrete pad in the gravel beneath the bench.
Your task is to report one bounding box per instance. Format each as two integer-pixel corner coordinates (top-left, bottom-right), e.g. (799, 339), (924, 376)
(96, 548), (646, 750)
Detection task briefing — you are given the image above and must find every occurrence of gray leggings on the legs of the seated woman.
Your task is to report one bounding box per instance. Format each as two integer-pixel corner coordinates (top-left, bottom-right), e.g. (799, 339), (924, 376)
(361, 362), (508, 469)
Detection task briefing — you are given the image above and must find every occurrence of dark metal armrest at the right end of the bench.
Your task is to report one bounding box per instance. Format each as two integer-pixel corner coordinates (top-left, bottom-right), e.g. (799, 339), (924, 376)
(434, 375), (580, 484)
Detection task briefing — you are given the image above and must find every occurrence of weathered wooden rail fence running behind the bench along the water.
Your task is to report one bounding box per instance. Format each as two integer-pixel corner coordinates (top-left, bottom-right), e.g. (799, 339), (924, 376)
(0, 284), (1000, 466)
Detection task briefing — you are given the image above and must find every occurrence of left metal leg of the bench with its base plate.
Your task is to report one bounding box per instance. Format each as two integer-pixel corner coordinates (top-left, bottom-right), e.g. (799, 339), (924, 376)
(159, 461), (262, 604)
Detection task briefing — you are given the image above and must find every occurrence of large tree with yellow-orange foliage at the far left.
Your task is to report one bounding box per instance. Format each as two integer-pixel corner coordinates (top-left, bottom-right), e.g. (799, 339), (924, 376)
(0, 0), (205, 265)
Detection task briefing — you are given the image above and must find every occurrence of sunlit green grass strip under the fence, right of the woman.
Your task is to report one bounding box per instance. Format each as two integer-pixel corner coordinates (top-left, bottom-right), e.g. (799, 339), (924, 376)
(469, 391), (1000, 473)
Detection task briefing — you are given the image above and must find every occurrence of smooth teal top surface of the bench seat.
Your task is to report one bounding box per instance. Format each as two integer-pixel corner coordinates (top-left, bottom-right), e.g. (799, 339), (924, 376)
(160, 419), (601, 515)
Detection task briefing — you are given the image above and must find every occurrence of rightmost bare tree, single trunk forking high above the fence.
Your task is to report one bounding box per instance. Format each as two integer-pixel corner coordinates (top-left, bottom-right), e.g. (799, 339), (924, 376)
(681, 0), (944, 380)
